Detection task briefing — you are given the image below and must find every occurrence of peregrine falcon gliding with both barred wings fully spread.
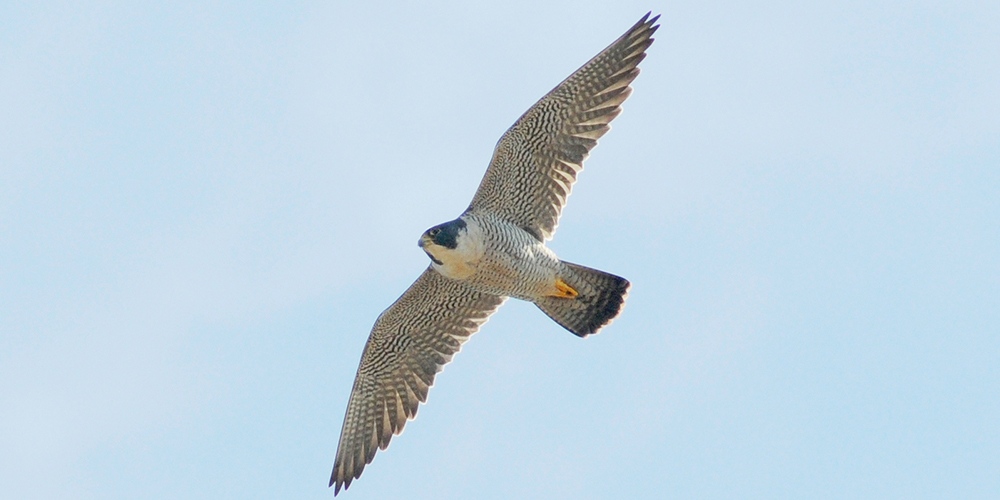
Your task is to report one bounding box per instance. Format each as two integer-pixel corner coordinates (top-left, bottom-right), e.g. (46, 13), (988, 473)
(330, 14), (659, 495)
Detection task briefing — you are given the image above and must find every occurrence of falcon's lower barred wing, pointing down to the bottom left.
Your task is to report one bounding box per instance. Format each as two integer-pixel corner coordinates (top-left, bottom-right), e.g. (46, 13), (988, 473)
(330, 267), (507, 495)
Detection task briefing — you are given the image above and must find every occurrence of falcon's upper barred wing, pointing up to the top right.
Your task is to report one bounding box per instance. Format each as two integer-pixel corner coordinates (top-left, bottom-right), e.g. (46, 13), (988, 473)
(468, 14), (660, 241)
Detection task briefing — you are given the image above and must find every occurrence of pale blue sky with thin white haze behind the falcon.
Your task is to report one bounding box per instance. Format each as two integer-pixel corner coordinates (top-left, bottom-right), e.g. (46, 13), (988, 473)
(0, 1), (1000, 500)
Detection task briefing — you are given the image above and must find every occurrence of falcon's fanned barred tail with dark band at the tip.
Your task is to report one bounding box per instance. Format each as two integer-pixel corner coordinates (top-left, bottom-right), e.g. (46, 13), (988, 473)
(535, 262), (631, 337)
